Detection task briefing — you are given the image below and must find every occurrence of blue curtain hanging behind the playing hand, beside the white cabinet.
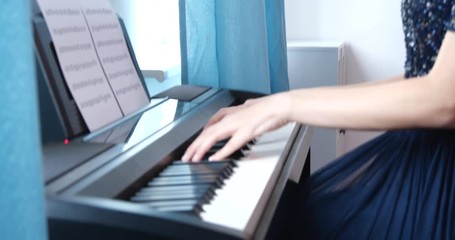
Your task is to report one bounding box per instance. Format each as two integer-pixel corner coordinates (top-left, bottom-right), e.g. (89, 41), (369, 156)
(180, 0), (289, 93)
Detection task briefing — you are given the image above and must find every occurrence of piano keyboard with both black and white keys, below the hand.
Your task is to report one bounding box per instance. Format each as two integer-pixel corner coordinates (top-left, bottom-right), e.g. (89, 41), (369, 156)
(130, 123), (295, 235)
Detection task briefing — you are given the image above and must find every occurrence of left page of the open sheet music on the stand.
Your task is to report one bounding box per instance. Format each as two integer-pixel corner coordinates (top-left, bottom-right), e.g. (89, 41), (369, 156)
(38, 0), (123, 131)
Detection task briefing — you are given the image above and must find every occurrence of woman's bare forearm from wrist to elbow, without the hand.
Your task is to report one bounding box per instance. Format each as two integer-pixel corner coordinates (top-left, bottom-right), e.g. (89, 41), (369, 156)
(283, 77), (453, 130)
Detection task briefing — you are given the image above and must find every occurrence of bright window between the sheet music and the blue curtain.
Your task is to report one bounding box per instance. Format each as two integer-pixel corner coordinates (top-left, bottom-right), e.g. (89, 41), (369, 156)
(110, 0), (181, 95)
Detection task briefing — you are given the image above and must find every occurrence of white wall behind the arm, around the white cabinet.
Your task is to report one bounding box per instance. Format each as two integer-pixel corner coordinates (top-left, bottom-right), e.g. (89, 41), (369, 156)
(285, 0), (405, 153)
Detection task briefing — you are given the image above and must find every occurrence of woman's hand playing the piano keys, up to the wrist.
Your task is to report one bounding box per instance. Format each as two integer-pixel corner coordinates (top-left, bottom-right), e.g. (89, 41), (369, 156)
(182, 94), (287, 162)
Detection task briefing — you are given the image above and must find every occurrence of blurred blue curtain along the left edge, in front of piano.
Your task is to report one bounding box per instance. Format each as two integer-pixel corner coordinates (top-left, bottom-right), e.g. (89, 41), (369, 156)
(0, 0), (47, 240)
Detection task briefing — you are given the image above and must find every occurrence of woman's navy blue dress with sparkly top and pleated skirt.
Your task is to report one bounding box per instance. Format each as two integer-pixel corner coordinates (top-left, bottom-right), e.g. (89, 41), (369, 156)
(296, 0), (455, 240)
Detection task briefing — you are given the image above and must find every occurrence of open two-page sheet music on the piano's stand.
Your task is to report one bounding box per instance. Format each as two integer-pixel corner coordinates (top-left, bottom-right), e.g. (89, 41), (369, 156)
(38, 0), (149, 131)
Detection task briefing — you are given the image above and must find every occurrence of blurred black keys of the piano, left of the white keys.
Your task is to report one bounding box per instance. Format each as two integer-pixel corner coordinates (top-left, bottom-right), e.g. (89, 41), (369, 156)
(130, 161), (235, 215)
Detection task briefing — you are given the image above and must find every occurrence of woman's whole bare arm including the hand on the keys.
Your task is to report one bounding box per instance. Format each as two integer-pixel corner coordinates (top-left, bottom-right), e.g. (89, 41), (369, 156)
(183, 32), (455, 161)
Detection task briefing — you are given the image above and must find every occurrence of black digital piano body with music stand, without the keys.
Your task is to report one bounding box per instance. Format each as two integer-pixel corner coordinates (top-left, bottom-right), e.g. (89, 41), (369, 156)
(33, 9), (311, 239)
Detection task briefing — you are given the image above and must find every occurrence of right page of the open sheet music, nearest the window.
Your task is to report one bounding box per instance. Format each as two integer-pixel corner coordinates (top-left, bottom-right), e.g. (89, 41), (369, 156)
(80, 0), (149, 115)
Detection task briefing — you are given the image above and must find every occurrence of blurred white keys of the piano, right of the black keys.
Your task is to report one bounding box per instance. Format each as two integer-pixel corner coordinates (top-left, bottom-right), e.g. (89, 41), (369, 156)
(201, 124), (295, 235)
